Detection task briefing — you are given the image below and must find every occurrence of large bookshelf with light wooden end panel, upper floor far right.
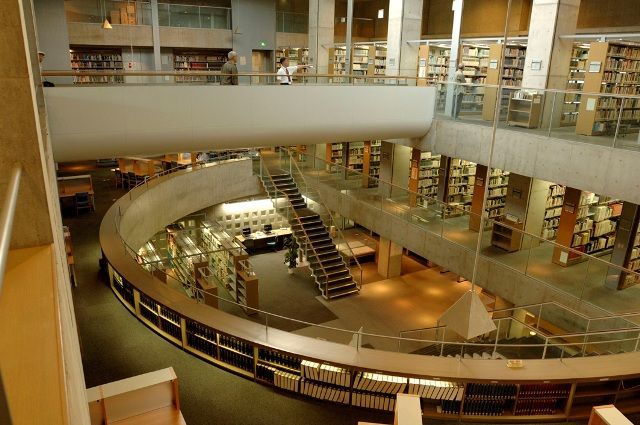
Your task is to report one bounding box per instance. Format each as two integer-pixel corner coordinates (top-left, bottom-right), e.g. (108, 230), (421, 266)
(576, 42), (640, 136)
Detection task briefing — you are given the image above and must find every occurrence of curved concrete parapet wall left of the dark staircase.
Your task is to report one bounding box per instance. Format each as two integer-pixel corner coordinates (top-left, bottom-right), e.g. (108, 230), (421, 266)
(120, 159), (262, 249)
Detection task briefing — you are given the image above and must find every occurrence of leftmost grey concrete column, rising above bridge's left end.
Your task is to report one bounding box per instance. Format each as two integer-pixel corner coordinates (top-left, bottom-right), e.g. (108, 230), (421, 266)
(33, 0), (72, 84)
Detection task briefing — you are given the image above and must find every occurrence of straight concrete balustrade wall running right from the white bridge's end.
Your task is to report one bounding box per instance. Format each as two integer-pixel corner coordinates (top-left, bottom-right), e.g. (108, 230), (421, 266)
(410, 120), (640, 203)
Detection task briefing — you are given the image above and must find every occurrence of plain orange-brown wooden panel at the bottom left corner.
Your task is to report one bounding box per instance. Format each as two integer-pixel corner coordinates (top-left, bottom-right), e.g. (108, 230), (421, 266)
(0, 245), (67, 425)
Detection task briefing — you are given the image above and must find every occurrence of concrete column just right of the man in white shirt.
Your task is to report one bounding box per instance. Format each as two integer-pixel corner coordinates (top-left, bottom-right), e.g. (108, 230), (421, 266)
(309, 0), (336, 74)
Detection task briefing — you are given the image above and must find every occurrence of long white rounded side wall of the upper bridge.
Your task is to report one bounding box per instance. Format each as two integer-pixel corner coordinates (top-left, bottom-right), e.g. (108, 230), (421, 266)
(45, 85), (435, 161)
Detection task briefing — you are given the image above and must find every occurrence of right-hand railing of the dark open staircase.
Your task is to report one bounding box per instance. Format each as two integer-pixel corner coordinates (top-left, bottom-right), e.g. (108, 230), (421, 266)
(280, 148), (363, 290)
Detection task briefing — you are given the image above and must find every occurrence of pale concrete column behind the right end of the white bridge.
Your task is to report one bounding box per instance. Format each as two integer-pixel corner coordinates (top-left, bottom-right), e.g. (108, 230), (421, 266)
(385, 0), (423, 85)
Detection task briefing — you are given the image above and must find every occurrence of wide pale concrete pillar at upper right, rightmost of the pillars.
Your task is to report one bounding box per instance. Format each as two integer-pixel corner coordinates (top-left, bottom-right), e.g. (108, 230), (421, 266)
(522, 0), (580, 127)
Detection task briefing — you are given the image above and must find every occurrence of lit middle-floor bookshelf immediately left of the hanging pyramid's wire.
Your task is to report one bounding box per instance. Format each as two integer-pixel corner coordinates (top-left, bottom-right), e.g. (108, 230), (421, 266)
(438, 156), (476, 217)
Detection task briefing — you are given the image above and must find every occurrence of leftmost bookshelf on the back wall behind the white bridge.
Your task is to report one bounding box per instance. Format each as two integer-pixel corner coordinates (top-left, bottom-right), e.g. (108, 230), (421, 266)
(69, 47), (124, 84)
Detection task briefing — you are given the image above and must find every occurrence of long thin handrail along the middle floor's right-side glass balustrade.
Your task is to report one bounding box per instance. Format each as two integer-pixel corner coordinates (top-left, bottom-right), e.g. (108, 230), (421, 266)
(299, 147), (640, 278)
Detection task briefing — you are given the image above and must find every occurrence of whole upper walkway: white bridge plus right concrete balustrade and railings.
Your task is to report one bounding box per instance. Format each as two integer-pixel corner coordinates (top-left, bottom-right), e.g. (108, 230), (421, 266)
(45, 71), (640, 203)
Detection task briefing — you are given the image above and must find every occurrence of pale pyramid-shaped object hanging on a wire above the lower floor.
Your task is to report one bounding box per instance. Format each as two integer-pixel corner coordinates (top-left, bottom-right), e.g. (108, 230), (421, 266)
(438, 290), (496, 340)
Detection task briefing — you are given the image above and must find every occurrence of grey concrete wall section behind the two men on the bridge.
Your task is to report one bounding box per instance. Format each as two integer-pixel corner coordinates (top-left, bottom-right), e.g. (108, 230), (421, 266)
(231, 0), (277, 72)
